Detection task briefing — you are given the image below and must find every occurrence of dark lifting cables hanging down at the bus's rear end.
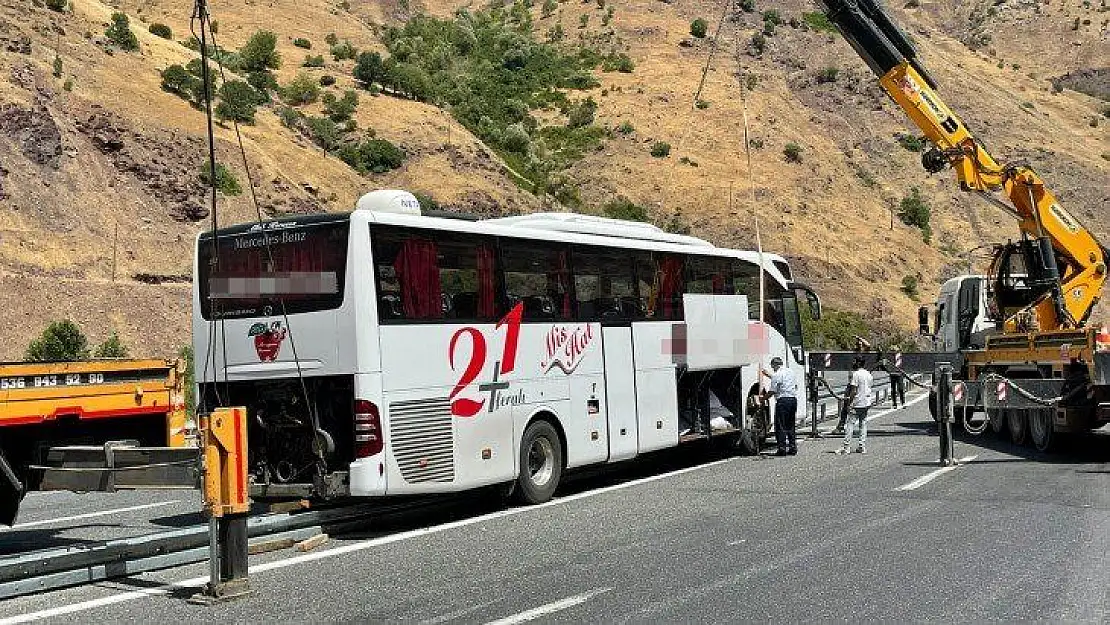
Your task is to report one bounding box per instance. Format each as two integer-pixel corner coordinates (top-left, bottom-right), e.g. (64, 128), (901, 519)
(190, 0), (327, 475)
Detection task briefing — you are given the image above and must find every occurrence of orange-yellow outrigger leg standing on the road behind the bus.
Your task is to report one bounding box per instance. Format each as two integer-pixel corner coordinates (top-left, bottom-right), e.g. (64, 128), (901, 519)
(190, 406), (251, 604)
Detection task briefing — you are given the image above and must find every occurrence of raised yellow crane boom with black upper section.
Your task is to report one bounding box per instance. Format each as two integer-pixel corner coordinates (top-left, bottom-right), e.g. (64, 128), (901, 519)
(819, 0), (1108, 332)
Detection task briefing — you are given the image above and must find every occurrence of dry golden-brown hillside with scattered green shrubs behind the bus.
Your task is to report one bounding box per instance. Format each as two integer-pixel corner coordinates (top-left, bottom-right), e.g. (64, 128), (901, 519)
(0, 0), (1110, 359)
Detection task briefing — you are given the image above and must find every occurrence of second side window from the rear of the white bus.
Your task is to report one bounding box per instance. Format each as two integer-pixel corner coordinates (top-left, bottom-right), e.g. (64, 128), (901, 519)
(501, 239), (573, 321)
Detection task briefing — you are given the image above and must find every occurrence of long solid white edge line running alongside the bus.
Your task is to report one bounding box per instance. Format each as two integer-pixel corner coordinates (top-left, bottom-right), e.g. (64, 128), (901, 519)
(0, 457), (740, 625)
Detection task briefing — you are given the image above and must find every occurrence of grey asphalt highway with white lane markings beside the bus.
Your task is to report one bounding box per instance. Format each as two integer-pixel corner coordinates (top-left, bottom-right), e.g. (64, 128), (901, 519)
(0, 386), (1110, 624)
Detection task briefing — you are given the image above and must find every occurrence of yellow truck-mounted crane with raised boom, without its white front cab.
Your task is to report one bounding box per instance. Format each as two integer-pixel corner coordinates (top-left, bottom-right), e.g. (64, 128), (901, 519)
(819, 0), (1110, 450)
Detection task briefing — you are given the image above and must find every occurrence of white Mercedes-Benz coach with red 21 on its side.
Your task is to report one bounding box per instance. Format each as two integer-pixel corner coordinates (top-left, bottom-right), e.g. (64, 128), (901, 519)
(193, 191), (819, 503)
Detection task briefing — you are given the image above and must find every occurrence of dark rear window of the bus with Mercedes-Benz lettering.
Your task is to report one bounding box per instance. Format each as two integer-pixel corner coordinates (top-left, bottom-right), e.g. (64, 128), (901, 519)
(198, 219), (350, 320)
